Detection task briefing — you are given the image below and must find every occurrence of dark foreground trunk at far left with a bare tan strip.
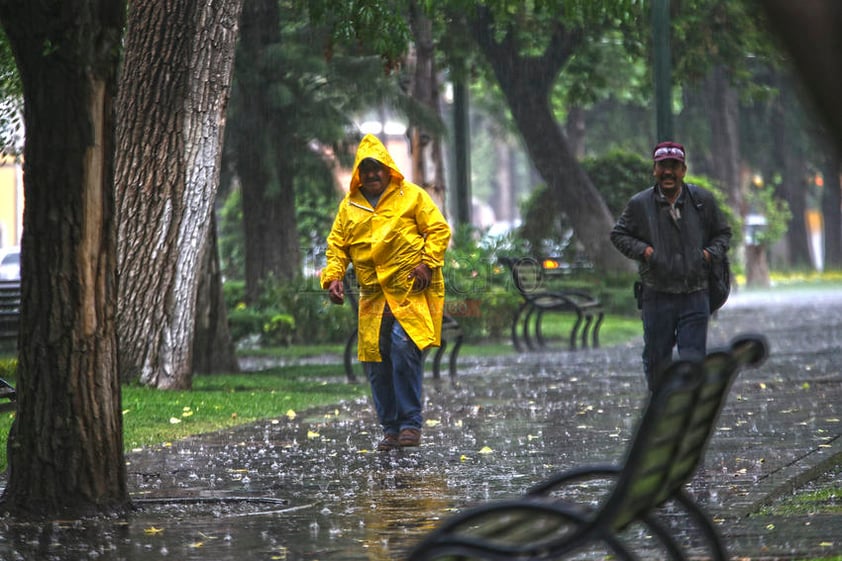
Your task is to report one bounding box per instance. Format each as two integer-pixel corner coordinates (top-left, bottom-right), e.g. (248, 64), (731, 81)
(0, 0), (129, 519)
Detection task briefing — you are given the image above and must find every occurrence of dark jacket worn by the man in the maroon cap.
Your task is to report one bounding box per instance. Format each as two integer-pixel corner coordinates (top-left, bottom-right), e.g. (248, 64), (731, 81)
(611, 184), (731, 294)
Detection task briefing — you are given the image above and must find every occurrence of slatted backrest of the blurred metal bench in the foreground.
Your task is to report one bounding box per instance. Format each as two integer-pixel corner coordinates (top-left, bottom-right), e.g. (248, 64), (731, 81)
(595, 336), (767, 531)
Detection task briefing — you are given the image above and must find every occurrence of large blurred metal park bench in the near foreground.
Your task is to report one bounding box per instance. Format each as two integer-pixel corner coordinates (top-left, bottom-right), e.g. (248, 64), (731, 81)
(409, 335), (768, 561)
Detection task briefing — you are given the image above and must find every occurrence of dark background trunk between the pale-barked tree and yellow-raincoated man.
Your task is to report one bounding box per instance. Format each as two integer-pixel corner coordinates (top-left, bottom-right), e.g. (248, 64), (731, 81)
(229, 0), (301, 302)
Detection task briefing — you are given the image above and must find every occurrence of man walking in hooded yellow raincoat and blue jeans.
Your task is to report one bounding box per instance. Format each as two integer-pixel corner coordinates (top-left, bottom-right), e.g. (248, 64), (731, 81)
(321, 134), (450, 450)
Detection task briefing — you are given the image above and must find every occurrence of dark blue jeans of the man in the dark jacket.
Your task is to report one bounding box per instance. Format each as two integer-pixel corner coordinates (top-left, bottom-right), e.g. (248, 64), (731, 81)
(642, 289), (710, 391)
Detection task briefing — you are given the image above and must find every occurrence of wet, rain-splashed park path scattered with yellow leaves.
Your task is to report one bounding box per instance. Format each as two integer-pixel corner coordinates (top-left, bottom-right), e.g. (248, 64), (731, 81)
(0, 291), (842, 561)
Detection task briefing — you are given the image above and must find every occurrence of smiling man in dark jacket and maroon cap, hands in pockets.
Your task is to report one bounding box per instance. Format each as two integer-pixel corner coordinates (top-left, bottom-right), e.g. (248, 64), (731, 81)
(611, 142), (731, 391)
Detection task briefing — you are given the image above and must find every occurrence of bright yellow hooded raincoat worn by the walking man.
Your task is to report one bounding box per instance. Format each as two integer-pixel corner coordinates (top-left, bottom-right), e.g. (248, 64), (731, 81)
(321, 134), (450, 362)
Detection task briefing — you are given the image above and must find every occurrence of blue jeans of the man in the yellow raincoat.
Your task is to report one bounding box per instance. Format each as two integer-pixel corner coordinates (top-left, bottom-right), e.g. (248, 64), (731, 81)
(363, 307), (424, 434)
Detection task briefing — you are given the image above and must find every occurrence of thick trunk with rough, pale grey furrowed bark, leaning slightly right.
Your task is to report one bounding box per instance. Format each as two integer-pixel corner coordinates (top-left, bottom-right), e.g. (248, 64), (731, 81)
(117, 0), (241, 389)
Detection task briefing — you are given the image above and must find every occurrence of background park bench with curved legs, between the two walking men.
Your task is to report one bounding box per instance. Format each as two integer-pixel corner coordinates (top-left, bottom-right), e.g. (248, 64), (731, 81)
(499, 257), (605, 352)
